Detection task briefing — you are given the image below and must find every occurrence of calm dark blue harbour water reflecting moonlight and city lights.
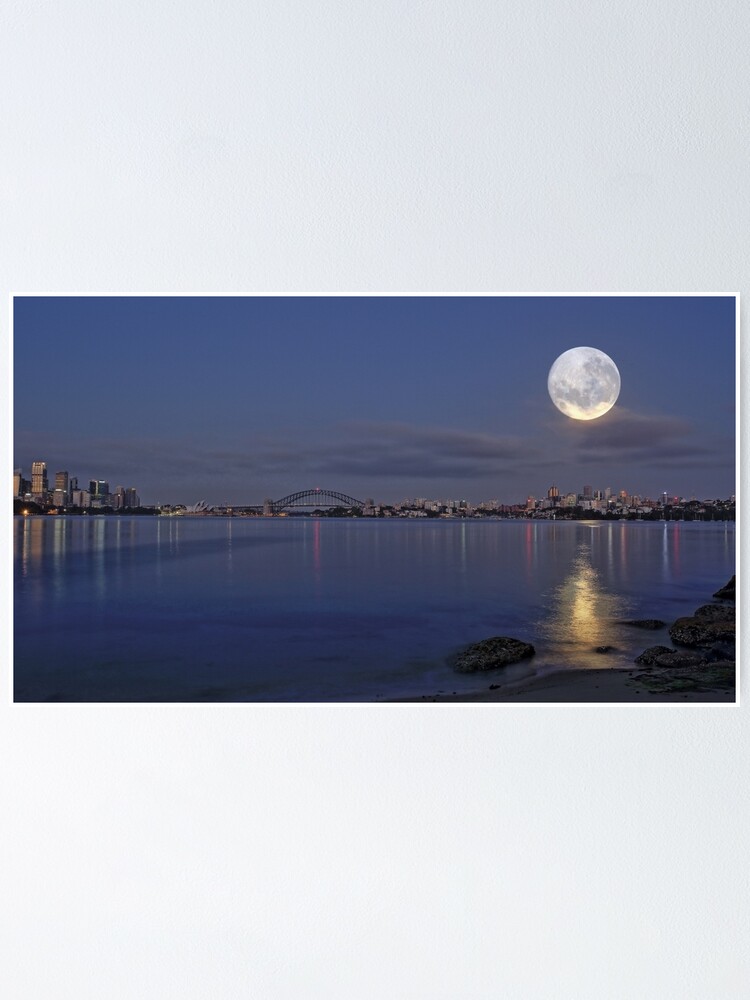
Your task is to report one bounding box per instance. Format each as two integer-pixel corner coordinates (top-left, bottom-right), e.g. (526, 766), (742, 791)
(14, 517), (735, 701)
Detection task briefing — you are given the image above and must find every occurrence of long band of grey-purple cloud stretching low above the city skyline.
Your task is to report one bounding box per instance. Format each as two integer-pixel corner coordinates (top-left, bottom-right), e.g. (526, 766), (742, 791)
(16, 407), (734, 503)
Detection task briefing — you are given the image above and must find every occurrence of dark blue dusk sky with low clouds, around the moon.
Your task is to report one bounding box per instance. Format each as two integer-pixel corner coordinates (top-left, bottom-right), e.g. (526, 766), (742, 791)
(14, 297), (735, 504)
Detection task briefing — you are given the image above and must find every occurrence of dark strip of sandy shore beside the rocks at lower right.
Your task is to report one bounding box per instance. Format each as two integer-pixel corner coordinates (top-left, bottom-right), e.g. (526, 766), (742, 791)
(400, 665), (735, 705)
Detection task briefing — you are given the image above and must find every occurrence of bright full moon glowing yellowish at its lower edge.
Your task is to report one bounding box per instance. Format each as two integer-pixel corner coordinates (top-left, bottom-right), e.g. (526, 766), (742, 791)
(547, 347), (620, 420)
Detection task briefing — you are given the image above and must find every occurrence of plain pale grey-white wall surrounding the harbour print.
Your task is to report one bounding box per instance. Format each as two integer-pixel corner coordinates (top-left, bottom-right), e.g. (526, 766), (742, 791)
(0, 0), (750, 1000)
